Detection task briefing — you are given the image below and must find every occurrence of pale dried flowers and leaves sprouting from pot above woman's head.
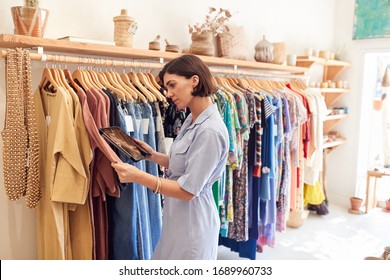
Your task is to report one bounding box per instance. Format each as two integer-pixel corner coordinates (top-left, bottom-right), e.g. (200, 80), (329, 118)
(188, 7), (232, 36)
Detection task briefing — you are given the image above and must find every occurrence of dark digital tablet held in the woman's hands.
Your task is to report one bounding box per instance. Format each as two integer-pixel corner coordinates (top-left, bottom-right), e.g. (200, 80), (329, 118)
(99, 126), (151, 162)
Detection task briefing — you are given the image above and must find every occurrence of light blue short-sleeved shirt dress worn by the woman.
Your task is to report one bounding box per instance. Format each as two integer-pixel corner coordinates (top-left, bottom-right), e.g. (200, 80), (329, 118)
(152, 104), (229, 260)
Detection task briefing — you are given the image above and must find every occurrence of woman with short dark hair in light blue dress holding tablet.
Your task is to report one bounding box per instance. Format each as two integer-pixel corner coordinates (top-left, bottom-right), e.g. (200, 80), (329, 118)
(112, 55), (228, 259)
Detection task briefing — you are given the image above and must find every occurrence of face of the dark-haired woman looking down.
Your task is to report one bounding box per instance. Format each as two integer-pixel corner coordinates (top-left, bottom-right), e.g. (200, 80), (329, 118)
(164, 73), (199, 110)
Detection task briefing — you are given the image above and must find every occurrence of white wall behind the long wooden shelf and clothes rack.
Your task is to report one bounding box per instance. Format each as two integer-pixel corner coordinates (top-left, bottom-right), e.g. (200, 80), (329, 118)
(0, 0), (338, 259)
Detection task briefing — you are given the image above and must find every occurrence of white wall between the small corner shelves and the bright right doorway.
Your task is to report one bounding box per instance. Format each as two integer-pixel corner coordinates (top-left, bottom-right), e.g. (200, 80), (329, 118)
(327, 0), (390, 205)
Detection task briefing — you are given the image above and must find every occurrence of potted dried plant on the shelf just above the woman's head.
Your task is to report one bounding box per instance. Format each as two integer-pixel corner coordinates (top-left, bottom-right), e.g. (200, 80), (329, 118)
(188, 7), (232, 56)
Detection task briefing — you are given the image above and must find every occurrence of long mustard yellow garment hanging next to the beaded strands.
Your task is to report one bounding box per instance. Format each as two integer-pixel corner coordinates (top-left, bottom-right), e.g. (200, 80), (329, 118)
(34, 88), (92, 259)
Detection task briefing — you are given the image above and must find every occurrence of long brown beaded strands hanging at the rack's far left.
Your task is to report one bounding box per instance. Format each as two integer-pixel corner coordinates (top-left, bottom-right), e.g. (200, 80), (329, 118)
(1, 49), (41, 208)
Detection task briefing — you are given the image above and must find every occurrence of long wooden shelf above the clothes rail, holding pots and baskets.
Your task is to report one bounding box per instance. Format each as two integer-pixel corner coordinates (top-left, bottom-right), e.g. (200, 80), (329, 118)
(0, 34), (308, 74)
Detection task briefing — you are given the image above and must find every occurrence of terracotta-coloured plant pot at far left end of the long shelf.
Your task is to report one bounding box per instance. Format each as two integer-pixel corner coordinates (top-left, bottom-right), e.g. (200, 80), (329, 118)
(11, 0), (49, 37)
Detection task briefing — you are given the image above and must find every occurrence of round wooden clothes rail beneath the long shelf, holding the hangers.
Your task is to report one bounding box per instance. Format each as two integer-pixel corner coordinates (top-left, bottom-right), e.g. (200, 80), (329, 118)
(0, 48), (310, 80)
